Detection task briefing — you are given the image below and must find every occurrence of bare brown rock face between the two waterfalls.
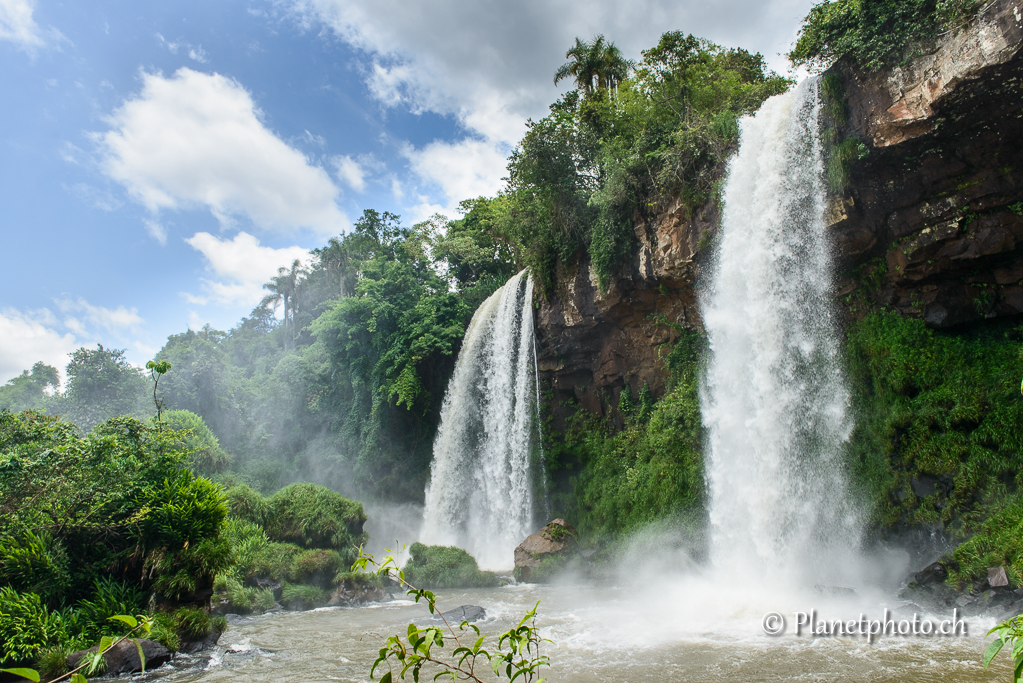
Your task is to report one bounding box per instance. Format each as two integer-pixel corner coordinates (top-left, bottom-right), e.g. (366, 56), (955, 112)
(536, 197), (718, 428)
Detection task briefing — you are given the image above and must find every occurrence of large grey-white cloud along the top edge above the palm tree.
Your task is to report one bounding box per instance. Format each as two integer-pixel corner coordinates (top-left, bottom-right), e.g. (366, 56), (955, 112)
(291, 0), (814, 144)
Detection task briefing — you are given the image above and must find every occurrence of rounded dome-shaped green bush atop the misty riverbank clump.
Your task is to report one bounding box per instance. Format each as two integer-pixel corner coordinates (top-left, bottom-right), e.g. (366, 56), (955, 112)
(263, 484), (367, 561)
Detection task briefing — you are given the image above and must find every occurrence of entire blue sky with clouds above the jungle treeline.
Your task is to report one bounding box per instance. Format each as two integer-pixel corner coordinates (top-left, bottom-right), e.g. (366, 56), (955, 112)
(0, 0), (813, 382)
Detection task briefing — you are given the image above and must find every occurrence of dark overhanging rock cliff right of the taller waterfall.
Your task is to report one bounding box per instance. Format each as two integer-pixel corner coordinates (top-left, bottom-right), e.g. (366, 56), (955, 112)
(829, 0), (1023, 327)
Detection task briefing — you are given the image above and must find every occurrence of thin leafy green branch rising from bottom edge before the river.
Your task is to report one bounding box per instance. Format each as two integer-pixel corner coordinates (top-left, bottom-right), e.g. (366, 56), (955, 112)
(352, 548), (550, 683)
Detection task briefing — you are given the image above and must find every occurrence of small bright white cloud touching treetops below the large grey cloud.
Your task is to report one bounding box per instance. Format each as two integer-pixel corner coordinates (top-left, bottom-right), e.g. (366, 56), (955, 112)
(405, 138), (507, 215)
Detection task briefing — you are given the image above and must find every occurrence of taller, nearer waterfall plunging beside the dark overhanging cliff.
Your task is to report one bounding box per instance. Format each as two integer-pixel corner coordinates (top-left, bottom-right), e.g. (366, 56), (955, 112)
(701, 79), (860, 585)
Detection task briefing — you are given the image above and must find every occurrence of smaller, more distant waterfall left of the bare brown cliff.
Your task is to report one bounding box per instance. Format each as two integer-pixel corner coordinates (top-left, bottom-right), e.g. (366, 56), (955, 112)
(422, 271), (538, 570)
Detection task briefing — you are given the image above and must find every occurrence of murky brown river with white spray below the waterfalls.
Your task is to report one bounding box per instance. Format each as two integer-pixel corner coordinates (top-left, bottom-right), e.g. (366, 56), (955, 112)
(154, 582), (1012, 683)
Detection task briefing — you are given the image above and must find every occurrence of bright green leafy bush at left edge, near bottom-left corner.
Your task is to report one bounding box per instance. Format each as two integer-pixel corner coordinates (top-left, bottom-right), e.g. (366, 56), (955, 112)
(0, 586), (66, 665)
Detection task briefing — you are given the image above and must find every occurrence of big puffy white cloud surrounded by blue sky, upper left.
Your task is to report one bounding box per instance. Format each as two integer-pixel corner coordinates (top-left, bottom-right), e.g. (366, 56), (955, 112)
(96, 69), (348, 233)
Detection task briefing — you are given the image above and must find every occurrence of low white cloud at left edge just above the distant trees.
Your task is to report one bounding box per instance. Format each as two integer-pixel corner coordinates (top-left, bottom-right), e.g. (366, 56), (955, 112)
(0, 308), (80, 382)
